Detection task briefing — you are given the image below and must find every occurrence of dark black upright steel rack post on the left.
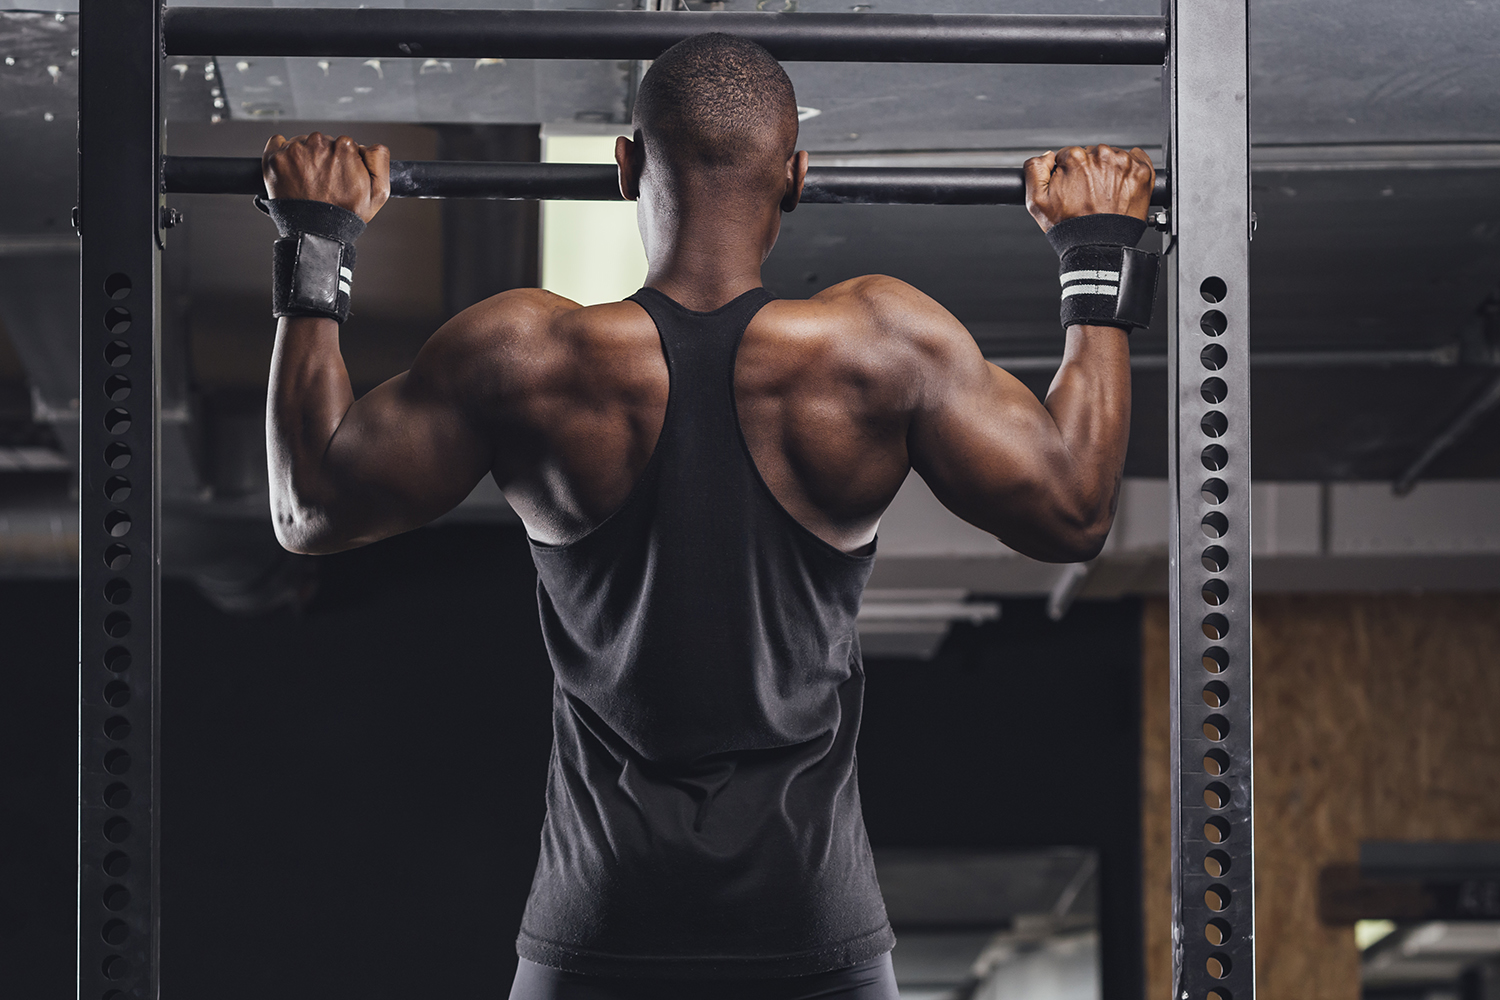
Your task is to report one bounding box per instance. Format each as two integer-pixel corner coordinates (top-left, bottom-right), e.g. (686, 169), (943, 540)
(78, 0), (162, 1000)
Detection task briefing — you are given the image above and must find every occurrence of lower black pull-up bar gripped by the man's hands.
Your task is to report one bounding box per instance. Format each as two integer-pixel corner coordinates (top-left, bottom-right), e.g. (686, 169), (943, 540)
(162, 156), (1169, 205)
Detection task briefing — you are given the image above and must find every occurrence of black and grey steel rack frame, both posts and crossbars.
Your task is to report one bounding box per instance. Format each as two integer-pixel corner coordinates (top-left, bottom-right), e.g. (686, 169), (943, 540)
(78, 0), (1256, 1000)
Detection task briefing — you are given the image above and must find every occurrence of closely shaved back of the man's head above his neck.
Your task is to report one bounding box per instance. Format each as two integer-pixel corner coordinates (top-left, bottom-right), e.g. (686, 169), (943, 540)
(635, 31), (797, 180)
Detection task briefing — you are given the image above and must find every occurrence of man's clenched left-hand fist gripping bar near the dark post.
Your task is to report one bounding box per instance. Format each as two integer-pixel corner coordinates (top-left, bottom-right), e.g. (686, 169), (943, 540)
(261, 132), (390, 222)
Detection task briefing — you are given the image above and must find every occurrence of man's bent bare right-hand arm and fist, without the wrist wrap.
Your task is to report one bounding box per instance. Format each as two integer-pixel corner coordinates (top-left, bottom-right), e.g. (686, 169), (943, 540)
(908, 147), (1154, 562)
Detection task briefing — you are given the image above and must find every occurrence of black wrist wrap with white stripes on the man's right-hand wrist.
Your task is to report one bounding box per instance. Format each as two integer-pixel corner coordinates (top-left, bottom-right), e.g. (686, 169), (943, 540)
(1047, 214), (1158, 333)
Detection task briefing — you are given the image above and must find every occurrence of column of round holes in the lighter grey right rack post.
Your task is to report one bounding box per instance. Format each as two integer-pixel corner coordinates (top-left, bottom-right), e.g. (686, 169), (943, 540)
(1199, 277), (1233, 1000)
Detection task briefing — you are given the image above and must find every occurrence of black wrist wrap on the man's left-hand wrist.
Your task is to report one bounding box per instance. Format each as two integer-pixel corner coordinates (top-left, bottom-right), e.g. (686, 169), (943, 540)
(255, 198), (365, 322)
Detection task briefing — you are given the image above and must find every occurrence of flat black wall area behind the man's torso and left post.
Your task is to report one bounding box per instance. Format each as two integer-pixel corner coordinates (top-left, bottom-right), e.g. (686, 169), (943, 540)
(0, 528), (1142, 1000)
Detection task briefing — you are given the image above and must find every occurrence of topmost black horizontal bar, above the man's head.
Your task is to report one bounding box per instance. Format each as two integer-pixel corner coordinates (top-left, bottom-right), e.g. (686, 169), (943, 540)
(164, 6), (1167, 66)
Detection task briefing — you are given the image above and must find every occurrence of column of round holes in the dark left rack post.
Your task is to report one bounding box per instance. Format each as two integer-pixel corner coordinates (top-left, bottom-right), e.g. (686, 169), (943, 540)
(99, 273), (135, 1000)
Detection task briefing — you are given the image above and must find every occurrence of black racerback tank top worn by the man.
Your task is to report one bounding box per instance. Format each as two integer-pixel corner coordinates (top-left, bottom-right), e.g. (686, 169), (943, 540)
(516, 288), (896, 978)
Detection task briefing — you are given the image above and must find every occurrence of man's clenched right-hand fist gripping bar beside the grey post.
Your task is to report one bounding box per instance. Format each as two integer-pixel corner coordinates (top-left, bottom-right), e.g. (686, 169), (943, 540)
(1023, 145), (1157, 232)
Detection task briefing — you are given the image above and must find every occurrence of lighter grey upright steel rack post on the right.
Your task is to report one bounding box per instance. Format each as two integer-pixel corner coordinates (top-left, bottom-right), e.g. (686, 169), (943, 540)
(1164, 0), (1256, 1000)
